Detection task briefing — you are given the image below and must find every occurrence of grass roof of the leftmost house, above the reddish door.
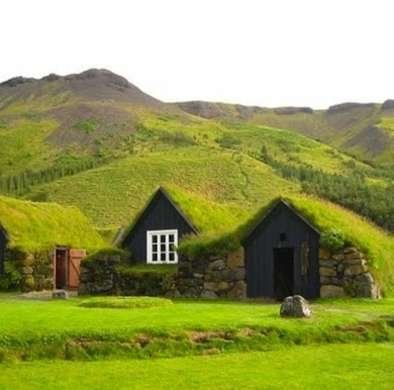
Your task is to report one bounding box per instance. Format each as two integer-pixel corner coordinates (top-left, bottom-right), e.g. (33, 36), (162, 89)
(0, 196), (104, 252)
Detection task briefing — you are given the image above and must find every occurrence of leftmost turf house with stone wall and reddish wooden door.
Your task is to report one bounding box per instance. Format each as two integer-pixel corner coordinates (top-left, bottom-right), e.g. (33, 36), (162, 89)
(0, 197), (104, 291)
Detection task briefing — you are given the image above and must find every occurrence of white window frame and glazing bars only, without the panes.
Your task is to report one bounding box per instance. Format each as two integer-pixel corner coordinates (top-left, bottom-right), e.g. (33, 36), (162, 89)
(146, 229), (178, 264)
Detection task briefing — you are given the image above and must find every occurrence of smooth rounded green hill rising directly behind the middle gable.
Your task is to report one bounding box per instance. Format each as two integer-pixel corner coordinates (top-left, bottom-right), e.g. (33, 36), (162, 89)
(29, 146), (299, 227)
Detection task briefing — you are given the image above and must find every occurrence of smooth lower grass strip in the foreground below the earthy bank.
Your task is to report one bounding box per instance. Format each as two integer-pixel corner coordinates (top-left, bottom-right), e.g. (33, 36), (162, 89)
(0, 343), (394, 390)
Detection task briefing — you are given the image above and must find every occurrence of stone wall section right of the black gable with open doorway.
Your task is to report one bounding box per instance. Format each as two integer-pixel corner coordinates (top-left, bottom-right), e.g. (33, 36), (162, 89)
(319, 247), (380, 298)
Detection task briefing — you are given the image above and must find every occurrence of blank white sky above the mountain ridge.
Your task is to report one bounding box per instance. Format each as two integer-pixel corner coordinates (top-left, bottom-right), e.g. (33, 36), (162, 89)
(0, 0), (394, 108)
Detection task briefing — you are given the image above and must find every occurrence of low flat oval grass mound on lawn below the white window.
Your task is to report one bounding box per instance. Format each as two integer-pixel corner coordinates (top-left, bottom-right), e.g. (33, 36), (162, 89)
(79, 297), (172, 309)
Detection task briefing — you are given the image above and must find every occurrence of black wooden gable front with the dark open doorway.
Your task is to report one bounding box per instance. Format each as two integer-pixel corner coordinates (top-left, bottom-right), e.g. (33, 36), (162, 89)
(244, 200), (320, 299)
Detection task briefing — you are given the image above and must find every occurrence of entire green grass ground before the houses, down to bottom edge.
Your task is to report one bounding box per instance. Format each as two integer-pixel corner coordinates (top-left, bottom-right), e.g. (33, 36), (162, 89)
(0, 294), (394, 390)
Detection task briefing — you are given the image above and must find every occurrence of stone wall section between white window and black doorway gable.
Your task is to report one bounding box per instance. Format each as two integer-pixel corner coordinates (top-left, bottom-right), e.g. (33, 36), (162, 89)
(176, 249), (246, 298)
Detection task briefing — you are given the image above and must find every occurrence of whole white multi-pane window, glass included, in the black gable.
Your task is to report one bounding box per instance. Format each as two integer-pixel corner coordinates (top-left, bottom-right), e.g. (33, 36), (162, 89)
(146, 230), (178, 264)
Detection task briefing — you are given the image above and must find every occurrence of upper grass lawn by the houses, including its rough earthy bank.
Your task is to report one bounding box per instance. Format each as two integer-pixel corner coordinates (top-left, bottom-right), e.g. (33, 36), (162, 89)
(0, 295), (394, 361)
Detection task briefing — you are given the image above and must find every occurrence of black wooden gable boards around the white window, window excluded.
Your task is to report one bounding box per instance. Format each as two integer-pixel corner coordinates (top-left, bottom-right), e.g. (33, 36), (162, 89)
(121, 188), (197, 262)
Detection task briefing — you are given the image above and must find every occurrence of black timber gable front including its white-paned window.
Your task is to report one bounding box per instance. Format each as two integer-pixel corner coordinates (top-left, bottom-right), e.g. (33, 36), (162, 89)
(120, 188), (197, 264)
